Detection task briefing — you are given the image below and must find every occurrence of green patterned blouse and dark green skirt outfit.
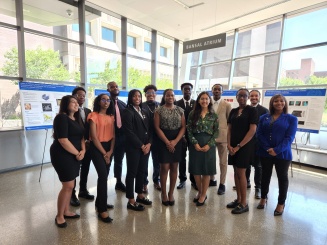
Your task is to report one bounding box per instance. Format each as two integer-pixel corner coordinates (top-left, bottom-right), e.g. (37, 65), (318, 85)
(187, 111), (218, 175)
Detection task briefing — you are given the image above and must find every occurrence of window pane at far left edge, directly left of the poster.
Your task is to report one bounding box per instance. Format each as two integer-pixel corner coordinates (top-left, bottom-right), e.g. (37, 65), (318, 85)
(0, 79), (23, 130)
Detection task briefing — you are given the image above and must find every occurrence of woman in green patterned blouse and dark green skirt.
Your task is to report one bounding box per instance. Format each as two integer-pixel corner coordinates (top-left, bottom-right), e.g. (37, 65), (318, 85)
(187, 92), (218, 206)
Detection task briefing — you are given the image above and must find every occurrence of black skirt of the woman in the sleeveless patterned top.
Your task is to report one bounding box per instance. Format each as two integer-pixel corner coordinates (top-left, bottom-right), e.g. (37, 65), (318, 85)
(158, 129), (182, 163)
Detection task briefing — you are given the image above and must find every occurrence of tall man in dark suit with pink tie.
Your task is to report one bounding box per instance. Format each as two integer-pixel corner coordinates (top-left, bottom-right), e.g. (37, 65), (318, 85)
(107, 81), (126, 192)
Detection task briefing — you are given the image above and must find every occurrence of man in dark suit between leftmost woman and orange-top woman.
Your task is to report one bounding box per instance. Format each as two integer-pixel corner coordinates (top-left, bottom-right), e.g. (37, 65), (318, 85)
(70, 87), (94, 207)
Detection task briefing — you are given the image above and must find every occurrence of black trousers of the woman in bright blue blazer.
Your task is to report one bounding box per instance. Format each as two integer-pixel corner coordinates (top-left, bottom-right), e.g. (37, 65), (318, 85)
(261, 157), (291, 205)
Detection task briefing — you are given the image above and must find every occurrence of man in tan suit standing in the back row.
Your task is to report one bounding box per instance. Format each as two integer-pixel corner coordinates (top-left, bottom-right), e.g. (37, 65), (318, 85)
(210, 84), (232, 195)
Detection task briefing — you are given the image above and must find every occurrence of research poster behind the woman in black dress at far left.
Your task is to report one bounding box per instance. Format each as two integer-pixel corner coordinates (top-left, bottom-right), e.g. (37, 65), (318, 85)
(19, 82), (75, 130)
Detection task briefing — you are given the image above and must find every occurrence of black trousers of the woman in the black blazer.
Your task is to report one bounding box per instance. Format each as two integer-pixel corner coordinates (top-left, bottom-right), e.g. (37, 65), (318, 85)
(126, 147), (149, 199)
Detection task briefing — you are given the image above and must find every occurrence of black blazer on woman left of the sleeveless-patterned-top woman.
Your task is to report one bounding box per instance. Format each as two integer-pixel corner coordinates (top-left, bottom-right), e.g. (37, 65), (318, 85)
(122, 107), (152, 150)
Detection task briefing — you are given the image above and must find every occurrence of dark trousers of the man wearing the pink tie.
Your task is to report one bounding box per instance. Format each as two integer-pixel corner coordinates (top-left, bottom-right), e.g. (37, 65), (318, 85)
(113, 129), (126, 180)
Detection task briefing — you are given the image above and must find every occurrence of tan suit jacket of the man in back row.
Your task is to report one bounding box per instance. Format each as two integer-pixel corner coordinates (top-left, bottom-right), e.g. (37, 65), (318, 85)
(215, 99), (232, 143)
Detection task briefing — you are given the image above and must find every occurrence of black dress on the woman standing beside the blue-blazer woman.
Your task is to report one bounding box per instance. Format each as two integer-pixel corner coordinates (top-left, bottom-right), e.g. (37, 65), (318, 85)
(227, 105), (258, 168)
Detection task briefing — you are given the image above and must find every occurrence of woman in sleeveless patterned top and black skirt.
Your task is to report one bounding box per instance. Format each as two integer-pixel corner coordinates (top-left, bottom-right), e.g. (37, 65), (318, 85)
(154, 89), (185, 206)
